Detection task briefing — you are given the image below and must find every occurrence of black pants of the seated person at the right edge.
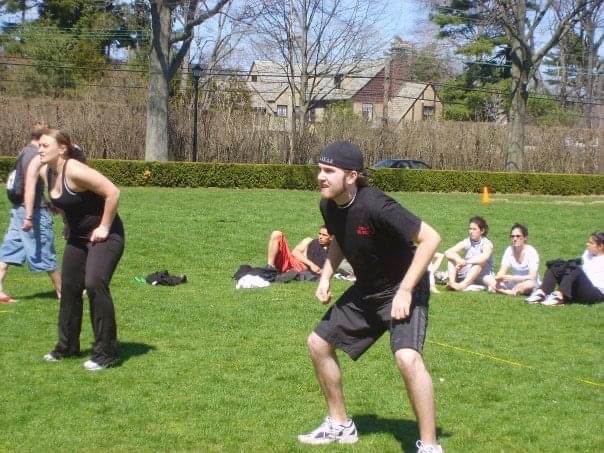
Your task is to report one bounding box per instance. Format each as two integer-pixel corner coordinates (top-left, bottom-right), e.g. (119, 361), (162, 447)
(541, 262), (604, 304)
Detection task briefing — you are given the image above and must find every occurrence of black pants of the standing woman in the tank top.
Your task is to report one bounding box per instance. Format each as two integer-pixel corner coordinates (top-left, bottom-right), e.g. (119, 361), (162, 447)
(53, 228), (124, 364)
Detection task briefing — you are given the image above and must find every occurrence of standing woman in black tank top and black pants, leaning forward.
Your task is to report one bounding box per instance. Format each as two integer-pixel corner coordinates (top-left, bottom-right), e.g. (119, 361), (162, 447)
(39, 129), (124, 371)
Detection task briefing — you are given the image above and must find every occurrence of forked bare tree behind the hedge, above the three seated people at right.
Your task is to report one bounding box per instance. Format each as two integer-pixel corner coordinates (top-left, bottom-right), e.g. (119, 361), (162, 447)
(491, 0), (598, 171)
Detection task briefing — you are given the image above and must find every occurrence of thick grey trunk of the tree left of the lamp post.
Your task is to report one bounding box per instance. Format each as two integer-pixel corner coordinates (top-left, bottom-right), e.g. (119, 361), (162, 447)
(145, 2), (172, 161)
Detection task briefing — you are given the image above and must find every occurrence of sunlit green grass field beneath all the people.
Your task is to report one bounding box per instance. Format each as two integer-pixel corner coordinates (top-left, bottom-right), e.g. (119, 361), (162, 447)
(0, 188), (604, 452)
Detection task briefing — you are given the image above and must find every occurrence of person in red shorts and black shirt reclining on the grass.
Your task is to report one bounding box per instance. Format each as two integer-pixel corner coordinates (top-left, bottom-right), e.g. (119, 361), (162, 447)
(266, 225), (331, 275)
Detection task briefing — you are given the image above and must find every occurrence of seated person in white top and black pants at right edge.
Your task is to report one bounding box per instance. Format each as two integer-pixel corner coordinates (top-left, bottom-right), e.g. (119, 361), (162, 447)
(525, 231), (604, 305)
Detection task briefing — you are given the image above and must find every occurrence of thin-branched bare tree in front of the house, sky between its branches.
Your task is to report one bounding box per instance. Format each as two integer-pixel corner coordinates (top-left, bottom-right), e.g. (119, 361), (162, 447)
(254, 0), (384, 163)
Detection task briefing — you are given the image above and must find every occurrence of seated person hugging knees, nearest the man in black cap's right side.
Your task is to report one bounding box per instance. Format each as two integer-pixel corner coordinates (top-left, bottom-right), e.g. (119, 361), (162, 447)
(445, 216), (493, 291)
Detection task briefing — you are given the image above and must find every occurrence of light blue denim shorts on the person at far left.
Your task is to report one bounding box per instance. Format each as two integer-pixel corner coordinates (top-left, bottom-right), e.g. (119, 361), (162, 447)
(0, 206), (57, 272)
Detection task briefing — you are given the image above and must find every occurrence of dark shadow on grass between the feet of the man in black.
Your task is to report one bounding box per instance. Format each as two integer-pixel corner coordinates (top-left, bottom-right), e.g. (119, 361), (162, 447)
(352, 414), (451, 453)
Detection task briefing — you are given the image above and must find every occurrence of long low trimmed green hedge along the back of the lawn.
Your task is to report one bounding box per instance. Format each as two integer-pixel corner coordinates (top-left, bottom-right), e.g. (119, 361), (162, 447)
(0, 157), (604, 195)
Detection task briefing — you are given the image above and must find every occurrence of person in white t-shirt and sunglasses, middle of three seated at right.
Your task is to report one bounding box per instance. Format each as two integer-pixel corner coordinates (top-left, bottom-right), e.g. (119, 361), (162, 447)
(484, 223), (540, 296)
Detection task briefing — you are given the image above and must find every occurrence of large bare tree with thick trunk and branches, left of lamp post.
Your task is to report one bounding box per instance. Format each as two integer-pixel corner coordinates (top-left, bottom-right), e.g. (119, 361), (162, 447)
(145, 0), (231, 160)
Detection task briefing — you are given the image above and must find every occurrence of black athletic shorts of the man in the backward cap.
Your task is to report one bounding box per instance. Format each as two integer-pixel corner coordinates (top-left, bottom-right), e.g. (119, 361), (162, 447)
(315, 279), (430, 360)
